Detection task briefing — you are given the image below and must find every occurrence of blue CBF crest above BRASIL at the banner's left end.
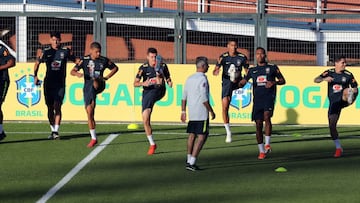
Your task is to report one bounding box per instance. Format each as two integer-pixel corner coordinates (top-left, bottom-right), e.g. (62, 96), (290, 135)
(16, 75), (41, 108)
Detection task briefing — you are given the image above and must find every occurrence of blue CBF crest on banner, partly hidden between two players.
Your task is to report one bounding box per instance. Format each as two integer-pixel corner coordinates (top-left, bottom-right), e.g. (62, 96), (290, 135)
(230, 82), (252, 110)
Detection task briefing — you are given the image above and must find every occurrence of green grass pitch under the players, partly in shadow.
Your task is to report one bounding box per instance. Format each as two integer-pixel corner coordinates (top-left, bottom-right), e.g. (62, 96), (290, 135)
(0, 123), (360, 203)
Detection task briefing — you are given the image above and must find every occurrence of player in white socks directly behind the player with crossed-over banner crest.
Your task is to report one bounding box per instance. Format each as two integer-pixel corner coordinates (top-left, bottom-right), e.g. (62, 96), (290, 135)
(213, 40), (249, 143)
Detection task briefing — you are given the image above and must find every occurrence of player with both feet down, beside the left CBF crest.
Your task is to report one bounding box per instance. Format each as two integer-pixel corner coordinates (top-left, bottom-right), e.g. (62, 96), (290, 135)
(34, 31), (77, 139)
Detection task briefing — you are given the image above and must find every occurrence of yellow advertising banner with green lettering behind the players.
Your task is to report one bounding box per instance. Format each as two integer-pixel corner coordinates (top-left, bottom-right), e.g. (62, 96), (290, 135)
(3, 63), (360, 125)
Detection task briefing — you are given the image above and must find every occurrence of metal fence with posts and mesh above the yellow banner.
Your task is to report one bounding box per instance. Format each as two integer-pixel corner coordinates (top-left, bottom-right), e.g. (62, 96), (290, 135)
(0, 0), (360, 65)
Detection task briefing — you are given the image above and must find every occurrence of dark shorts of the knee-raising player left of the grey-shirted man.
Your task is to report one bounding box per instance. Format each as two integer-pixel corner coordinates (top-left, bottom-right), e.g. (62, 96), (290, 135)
(142, 86), (166, 111)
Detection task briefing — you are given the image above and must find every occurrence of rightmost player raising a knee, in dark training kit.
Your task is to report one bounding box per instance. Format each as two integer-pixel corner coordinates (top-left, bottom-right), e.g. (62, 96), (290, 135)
(314, 56), (358, 158)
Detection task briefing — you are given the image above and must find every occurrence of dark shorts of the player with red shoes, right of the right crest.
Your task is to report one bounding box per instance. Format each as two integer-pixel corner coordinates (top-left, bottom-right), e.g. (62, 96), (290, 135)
(251, 98), (275, 121)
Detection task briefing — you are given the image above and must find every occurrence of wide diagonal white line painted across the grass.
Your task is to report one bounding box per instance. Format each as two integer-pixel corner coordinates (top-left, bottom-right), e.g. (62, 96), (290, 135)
(37, 134), (119, 203)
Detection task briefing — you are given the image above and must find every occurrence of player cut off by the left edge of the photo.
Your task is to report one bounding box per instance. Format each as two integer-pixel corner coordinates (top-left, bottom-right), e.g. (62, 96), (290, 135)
(0, 44), (15, 141)
